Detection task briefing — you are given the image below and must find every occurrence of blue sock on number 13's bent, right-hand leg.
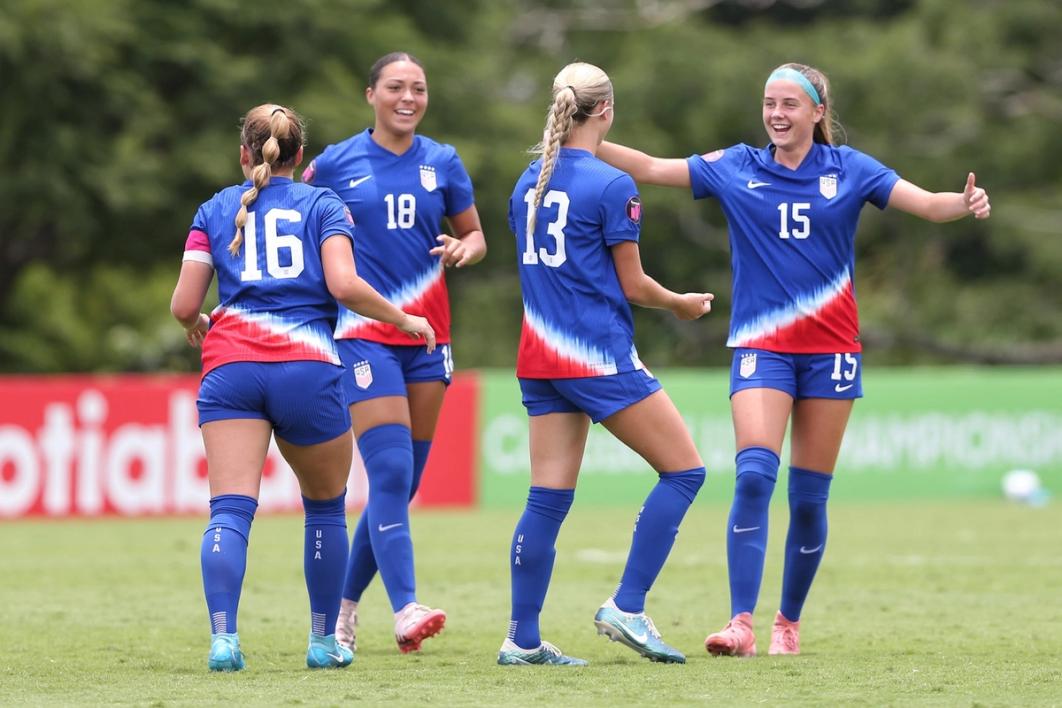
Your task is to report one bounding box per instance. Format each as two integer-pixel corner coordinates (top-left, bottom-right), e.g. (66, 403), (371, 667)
(613, 467), (704, 612)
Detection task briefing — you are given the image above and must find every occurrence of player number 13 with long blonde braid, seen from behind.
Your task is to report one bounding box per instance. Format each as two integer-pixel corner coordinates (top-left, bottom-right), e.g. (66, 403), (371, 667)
(498, 63), (713, 666)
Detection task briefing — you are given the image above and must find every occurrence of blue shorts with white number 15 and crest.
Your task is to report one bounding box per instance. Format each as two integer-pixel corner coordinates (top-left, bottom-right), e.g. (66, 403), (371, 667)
(731, 348), (862, 400)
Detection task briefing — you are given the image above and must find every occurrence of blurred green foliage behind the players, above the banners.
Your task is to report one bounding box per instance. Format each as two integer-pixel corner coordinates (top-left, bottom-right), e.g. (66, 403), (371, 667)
(0, 0), (1062, 373)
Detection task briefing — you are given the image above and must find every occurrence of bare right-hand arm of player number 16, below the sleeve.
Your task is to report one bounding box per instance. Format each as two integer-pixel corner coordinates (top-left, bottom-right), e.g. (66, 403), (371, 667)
(321, 235), (435, 351)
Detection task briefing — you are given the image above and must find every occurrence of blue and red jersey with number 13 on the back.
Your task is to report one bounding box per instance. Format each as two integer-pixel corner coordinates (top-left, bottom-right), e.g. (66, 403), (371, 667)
(509, 148), (643, 379)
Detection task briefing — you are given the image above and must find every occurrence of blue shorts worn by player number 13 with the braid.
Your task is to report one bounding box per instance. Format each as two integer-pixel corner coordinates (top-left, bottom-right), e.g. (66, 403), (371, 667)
(520, 369), (661, 422)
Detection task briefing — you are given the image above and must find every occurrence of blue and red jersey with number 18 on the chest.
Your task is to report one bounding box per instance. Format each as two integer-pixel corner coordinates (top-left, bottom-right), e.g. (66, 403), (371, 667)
(303, 129), (474, 346)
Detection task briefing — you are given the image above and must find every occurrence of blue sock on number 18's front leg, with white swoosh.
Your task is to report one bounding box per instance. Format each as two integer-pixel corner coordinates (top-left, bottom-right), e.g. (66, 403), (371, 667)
(358, 424), (416, 612)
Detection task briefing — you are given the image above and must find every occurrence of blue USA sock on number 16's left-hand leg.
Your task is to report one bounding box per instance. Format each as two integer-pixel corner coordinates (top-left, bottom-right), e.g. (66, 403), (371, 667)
(200, 495), (258, 634)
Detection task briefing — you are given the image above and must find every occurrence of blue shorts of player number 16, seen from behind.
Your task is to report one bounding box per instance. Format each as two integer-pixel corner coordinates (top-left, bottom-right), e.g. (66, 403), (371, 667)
(195, 361), (350, 445)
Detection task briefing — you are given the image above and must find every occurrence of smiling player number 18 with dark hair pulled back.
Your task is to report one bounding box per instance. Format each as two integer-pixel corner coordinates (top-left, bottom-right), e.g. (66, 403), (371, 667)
(303, 52), (486, 653)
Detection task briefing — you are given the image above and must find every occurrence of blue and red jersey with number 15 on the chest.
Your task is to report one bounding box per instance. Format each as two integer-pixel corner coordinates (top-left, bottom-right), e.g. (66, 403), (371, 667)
(687, 142), (900, 353)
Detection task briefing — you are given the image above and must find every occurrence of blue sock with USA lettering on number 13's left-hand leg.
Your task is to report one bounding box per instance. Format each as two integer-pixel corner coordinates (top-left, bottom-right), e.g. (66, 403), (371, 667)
(509, 487), (576, 649)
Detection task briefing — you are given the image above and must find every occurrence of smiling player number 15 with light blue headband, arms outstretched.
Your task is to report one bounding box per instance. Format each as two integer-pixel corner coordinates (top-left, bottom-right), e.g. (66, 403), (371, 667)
(599, 64), (991, 656)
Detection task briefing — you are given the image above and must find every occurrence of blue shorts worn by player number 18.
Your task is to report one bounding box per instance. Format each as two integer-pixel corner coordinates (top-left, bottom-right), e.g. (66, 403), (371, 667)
(336, 340), (453, 404)
